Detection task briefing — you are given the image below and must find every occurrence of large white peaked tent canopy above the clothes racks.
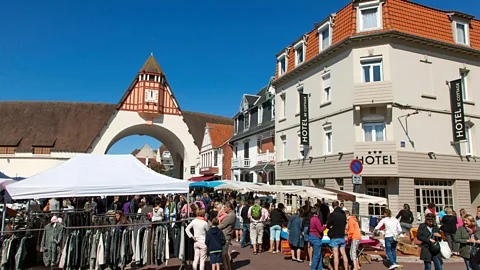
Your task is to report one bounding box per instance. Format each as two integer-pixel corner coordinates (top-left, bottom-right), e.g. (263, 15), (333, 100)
(7, 154), (189, 200)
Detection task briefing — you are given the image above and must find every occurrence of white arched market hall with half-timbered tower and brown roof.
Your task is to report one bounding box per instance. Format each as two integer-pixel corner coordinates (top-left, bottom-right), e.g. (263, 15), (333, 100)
(0, 55), (233, 180)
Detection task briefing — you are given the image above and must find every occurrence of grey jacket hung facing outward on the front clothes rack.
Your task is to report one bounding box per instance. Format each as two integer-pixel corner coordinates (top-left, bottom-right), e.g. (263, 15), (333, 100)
(40, 223), (64, 266)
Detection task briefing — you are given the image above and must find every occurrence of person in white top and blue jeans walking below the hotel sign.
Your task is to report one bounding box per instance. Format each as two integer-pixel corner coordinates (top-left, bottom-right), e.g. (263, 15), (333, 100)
(375, 209), (402, 269)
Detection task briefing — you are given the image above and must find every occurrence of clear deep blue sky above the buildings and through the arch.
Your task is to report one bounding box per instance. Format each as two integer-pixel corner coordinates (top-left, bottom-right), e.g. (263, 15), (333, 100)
(0, 0), (480, 153)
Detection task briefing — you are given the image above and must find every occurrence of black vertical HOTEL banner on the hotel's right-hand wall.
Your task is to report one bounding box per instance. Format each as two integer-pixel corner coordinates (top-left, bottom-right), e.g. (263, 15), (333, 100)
(450, 79), (467, 143)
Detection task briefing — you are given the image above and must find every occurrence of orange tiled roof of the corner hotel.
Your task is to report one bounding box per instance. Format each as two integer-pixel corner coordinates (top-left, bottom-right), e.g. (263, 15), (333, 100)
(276, 0), (480, 78)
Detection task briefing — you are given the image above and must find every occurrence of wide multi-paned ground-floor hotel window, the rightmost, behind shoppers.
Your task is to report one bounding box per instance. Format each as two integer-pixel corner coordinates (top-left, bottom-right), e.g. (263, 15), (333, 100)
(415, 179), (453, 222)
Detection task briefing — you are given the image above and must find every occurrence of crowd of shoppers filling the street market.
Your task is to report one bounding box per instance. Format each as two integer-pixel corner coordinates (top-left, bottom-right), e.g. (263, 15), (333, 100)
(17, 193), (480, 270)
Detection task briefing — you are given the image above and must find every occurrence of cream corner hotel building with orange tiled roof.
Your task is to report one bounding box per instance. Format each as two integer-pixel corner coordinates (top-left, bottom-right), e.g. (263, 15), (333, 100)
(273, 0), (480, 216)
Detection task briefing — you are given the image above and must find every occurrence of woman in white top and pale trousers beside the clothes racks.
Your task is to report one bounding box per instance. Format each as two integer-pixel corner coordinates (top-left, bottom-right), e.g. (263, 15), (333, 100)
(185, 209), (210, 270)
